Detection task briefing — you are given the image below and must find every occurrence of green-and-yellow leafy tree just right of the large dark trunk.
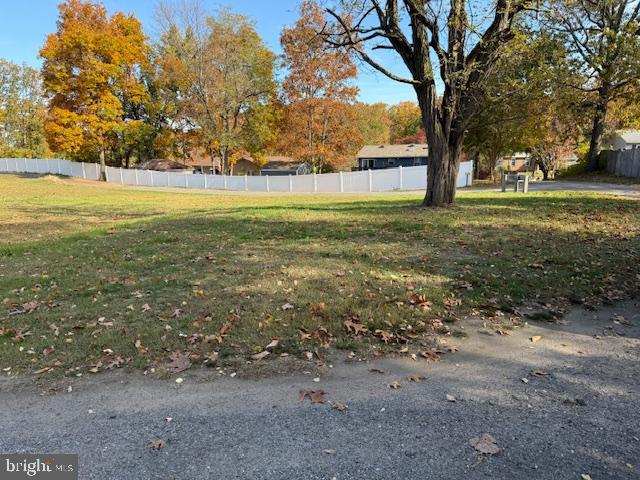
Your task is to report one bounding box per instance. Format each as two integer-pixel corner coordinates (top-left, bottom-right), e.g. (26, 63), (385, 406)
(465, 27), (579, 178)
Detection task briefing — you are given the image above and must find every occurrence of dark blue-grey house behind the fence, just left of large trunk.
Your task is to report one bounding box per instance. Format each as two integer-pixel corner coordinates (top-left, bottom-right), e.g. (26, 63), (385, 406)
(355, 143), (428, 170)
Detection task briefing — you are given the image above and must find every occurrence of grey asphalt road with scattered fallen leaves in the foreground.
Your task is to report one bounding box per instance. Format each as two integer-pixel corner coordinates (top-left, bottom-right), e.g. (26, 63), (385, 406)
(0, 302), (640, 480)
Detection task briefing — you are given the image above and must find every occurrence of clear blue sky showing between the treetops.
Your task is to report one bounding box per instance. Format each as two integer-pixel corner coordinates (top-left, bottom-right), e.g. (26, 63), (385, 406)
(0, 0), (415, 103)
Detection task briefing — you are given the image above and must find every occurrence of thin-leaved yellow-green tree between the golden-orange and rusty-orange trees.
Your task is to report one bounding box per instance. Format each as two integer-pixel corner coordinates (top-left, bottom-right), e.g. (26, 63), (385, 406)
(158, 1), (276, 172)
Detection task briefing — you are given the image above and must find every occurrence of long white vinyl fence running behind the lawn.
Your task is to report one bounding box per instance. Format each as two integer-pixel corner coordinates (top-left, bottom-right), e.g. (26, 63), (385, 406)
(0, 158), (473, 193)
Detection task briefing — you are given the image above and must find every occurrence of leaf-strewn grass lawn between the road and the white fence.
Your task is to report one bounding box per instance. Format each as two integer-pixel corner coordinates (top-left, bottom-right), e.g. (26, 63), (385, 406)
(0, 175), (640, 378)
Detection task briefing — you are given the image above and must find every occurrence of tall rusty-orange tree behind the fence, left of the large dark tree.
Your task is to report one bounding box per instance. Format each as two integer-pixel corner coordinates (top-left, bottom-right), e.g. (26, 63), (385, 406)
(279, 0), (361, 171)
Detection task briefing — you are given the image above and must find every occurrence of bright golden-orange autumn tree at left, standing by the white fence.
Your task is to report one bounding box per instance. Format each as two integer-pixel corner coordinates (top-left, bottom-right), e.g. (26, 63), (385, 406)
(40, 0), (147, 180)
